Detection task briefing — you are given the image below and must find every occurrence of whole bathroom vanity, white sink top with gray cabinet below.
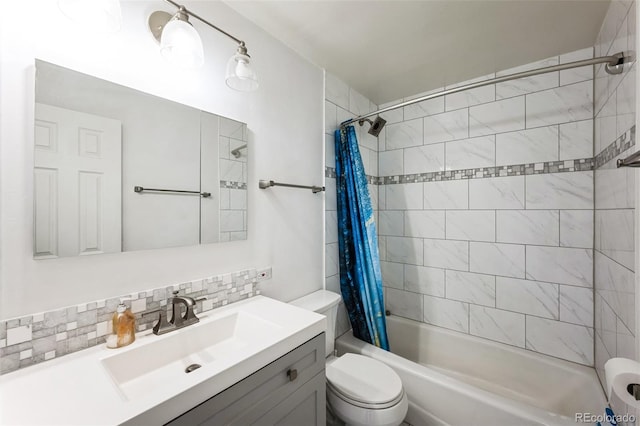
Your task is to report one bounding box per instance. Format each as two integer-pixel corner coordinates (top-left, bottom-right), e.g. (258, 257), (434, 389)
(0, 296), (326, 425)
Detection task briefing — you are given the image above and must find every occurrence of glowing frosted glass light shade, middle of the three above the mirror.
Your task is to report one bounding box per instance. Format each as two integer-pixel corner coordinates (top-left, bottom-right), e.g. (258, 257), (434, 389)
(160, 18), (204, 68)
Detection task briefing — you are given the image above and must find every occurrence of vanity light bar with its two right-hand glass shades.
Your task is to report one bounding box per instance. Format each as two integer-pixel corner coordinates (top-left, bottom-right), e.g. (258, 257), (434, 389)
(149, 0), (258, 92)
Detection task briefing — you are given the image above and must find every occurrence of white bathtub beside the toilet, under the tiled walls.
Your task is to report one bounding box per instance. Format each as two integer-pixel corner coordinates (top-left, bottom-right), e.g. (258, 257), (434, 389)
(336, 315), (606, 426)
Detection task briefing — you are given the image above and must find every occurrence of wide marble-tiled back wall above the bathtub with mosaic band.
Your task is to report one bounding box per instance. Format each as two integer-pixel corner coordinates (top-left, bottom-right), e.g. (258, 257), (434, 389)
(378, 48), (600, 365)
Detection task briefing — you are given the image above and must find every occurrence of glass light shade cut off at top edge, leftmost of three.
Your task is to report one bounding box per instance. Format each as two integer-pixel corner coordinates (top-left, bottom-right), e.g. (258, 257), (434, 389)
(58, 0), (122, 33)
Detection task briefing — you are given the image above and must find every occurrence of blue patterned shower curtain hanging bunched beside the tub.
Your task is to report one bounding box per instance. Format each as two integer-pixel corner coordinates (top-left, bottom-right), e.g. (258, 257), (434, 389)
(335, 126), (389, 350)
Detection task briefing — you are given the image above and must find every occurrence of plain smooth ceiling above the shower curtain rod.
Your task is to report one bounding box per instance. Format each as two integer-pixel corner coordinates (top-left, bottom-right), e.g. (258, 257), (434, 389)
(227, 0), (609, 104)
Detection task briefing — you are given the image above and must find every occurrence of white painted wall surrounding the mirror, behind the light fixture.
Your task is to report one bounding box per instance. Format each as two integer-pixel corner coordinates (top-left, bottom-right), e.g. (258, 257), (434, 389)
(0, 0), (323, 318)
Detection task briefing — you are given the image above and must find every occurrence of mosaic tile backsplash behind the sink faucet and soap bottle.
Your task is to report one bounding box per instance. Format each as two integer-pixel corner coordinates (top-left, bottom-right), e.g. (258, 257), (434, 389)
(0, 269), (259, 374)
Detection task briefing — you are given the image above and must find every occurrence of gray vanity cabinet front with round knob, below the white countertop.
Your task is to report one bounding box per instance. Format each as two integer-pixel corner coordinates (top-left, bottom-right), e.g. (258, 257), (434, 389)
(168, 333), (326, 426)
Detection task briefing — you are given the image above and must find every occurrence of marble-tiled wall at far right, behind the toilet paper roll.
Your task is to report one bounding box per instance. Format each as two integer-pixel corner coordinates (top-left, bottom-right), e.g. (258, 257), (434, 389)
(592, 0), (638, 384)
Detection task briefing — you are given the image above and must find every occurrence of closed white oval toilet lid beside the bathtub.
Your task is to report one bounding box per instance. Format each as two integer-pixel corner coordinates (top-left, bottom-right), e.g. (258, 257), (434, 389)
(326, 353), (402, 404)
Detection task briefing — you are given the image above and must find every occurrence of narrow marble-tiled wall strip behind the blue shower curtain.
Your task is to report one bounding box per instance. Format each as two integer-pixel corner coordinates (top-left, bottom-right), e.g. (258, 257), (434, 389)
(324, 72), (378, 337)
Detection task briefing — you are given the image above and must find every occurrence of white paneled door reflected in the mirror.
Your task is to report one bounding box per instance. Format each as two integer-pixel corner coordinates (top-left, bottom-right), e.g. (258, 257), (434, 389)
(34, 104), (122, 258)
